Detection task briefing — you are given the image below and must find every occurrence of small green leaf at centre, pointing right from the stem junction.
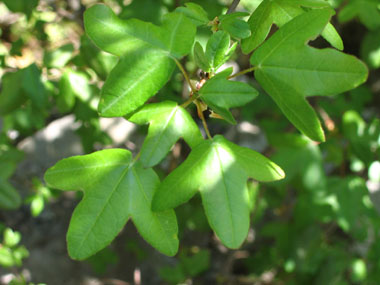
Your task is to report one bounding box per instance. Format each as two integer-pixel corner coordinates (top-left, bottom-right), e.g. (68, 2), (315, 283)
(199, 76), (258, 124)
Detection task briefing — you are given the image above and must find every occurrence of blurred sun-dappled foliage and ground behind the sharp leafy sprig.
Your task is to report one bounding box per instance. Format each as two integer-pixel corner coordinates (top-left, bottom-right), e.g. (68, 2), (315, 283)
(0, 0), (380, 284)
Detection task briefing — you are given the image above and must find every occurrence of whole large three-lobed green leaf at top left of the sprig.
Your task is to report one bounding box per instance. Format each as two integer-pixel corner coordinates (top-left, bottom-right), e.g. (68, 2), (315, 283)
(84, 4), (196, 117)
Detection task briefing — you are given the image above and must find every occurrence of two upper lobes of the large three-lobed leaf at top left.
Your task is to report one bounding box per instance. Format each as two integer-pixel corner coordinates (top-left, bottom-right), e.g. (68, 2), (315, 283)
(84, 4), (196, 57)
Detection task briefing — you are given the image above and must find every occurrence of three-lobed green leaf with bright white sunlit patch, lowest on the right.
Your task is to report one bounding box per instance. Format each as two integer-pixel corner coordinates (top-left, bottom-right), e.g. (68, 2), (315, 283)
(152, 135), (284, 248)
